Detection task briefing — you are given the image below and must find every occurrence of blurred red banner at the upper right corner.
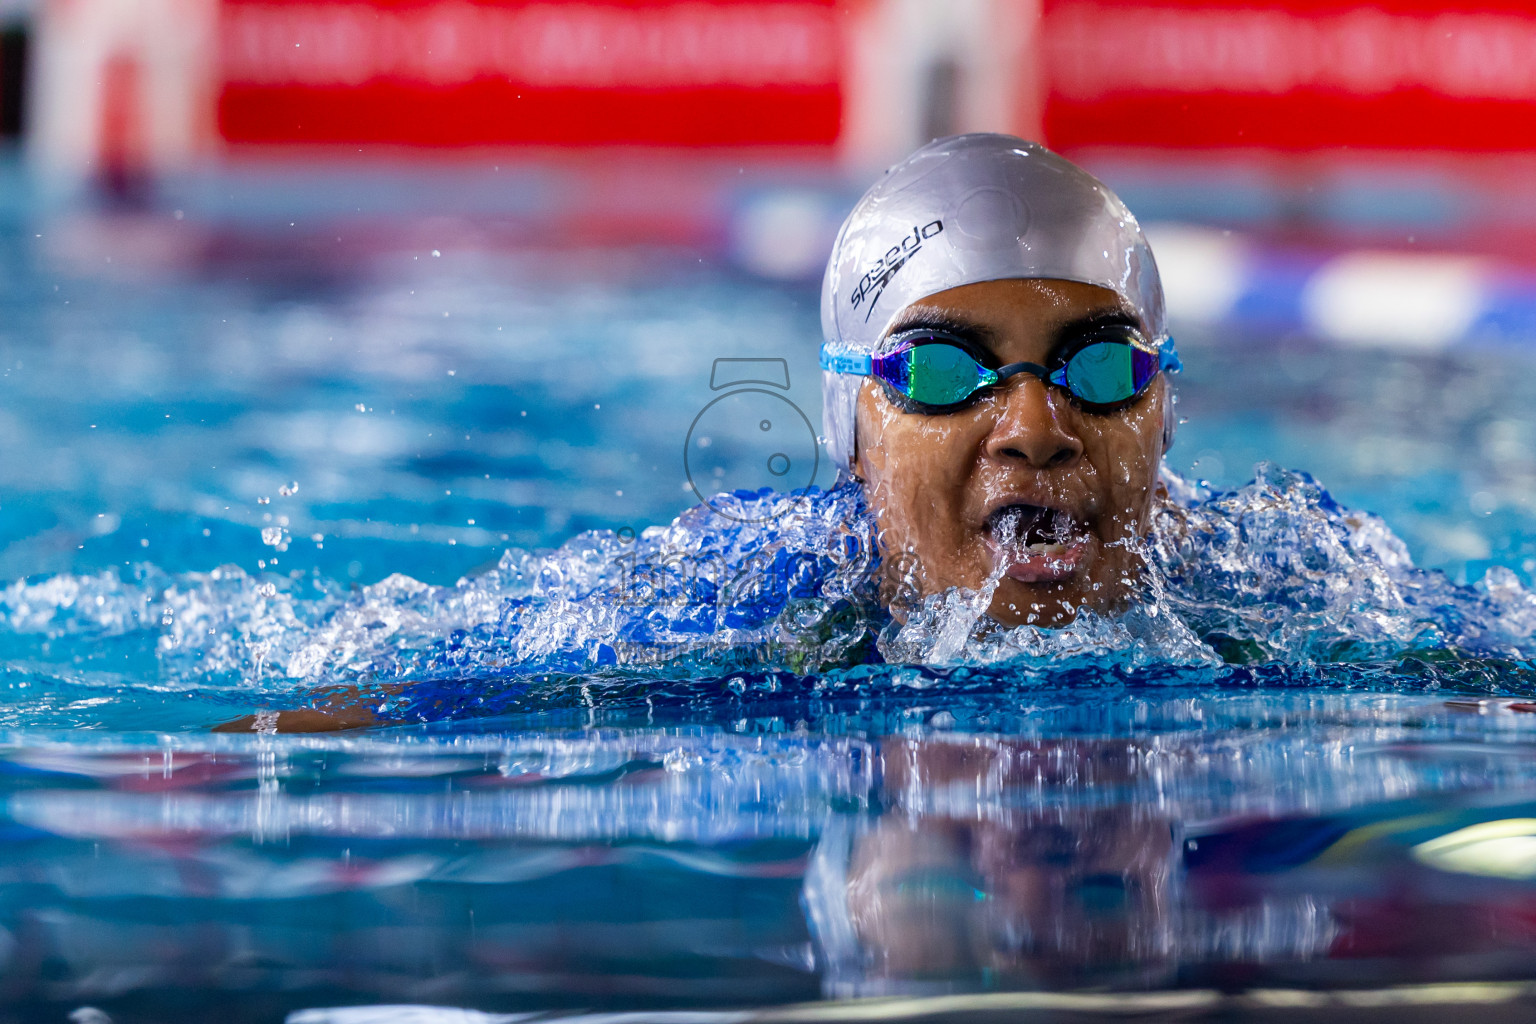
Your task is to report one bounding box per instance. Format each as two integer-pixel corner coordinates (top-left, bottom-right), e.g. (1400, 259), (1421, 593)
(1040, 0), (1536, 150)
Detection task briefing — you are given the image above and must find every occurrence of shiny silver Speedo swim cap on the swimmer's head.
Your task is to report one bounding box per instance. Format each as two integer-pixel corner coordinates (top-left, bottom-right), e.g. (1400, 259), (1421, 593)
(822, 132), (1174, 470)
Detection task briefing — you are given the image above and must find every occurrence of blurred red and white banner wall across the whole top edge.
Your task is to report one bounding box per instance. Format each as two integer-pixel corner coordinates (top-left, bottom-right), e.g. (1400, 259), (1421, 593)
(18, 0), (1536, 164)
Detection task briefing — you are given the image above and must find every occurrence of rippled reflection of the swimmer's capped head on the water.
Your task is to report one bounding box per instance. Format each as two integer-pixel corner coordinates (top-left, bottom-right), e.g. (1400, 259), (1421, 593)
(808, 738), (1177, 995)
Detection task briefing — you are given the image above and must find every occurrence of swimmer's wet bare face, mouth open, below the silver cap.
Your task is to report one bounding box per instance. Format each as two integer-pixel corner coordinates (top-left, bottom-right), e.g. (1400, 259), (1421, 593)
(856, 279), (1167, 626)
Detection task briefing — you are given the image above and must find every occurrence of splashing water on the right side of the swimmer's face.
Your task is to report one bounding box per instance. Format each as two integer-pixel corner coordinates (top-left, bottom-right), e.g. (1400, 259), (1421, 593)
(1150, 464), (1536, 663)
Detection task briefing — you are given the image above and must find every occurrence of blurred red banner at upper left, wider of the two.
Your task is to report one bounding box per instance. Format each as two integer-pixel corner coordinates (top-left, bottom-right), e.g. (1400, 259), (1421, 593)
(218, 0), (842, 146)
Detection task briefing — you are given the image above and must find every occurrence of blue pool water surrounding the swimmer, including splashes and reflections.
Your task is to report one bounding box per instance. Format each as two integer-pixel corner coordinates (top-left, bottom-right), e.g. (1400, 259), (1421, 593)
(0, 171), (1536, 1021)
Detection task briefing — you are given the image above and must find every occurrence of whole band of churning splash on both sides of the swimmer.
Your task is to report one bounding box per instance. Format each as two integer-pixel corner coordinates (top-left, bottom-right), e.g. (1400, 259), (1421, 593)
(0, 465), (1536, 718)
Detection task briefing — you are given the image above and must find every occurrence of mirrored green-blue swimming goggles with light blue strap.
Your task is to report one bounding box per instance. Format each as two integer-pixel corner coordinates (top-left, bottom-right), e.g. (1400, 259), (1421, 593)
(822, 324), (1184, 413)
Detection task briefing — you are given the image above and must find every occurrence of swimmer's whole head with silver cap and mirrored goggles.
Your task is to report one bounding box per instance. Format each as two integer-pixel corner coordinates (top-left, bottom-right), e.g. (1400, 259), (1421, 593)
(822, 134), (1177, 625)
